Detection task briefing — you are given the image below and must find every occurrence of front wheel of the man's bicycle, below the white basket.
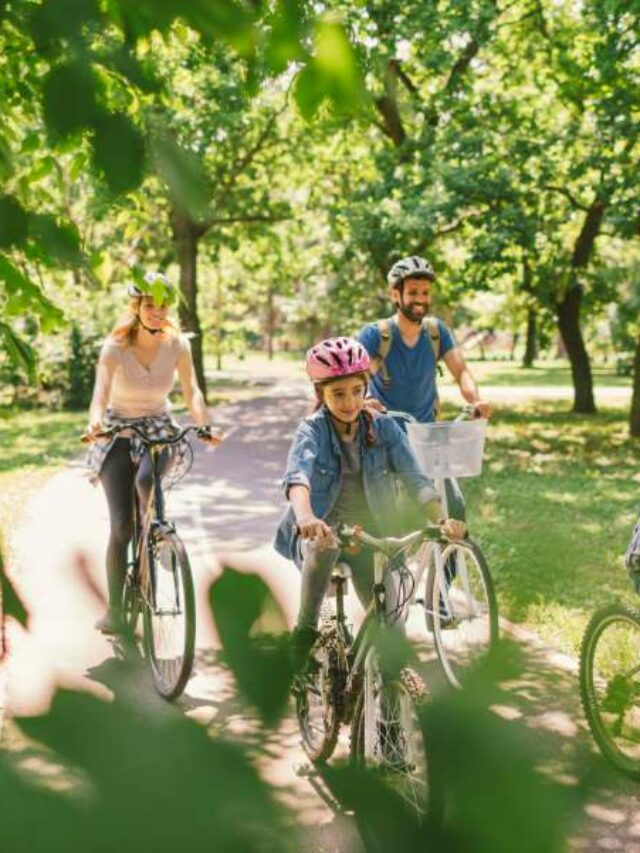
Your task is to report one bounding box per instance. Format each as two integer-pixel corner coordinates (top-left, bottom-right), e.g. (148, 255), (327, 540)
(425, 540), (498, 688)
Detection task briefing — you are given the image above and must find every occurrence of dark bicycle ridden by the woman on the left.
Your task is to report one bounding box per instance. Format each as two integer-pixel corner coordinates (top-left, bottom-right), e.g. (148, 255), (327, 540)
(87, 424), (210, 699)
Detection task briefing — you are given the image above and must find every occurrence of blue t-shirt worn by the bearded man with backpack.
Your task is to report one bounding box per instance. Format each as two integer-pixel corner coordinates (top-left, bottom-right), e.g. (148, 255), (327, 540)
(356, 320), (456, 423)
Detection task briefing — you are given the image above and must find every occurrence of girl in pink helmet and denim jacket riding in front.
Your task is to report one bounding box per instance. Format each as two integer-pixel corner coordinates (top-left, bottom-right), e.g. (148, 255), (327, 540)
(275, 337), (465, 669)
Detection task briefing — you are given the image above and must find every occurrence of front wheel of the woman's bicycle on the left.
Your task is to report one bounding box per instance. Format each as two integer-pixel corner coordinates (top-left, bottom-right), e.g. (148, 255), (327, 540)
(143, 533), (196, 699)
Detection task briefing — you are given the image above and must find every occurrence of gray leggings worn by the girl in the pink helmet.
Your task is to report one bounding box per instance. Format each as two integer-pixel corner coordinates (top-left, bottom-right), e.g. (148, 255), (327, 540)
(297, 540), (403, 629)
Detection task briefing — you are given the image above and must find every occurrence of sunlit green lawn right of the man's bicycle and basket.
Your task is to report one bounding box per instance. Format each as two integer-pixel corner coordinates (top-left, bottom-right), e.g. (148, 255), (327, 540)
(462, 401), (640, 653)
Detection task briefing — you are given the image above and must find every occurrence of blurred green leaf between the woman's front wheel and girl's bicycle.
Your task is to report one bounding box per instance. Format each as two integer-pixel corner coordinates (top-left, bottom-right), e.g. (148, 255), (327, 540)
(209, 568), (292, 723)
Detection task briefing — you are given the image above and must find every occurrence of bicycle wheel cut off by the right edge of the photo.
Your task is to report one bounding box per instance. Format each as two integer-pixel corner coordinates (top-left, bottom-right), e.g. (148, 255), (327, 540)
(580, 604), (640, 779)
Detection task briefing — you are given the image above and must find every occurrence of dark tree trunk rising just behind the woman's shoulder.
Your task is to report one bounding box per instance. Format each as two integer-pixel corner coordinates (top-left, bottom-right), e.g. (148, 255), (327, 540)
(171, 207), (207, 400)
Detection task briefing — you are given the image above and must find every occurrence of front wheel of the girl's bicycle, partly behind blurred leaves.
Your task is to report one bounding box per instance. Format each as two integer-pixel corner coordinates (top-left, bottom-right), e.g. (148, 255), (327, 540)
(351, 649), (434, 817)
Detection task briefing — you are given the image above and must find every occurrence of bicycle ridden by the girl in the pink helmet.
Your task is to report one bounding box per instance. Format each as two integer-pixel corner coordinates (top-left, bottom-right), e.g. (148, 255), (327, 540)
(296, 525), (443, 814)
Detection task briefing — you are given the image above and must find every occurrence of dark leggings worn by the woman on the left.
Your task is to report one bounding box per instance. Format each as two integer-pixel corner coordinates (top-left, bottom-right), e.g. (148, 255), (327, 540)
(100, 438), (170, 608)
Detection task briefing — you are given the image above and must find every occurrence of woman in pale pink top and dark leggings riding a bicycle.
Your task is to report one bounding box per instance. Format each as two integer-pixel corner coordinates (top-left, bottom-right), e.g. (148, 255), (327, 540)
(87, 272), (220, 634)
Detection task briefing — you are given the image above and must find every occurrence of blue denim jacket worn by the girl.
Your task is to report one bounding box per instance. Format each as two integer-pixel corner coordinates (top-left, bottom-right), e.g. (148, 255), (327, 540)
(274, 406), (438, 563)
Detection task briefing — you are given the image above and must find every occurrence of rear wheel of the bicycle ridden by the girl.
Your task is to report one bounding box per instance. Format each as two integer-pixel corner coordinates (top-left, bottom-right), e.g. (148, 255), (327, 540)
(296, 605), (346, 763)
